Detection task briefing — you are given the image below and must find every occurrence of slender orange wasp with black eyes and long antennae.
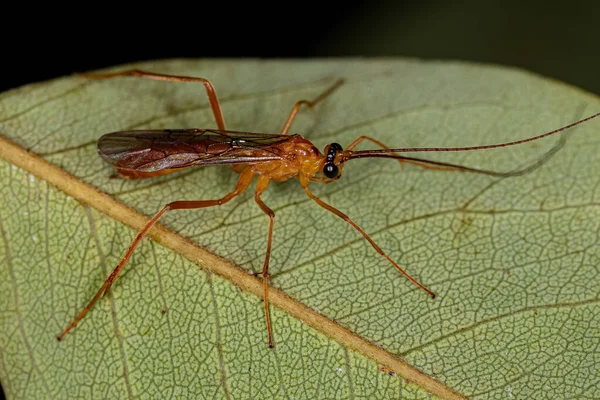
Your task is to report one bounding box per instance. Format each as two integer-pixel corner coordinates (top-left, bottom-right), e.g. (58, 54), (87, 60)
(57, 70), (600, 347)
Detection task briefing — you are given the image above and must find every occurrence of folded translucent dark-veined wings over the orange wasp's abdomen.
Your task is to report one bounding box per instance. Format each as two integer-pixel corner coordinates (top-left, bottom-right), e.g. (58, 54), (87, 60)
(98, 129), (290, 176)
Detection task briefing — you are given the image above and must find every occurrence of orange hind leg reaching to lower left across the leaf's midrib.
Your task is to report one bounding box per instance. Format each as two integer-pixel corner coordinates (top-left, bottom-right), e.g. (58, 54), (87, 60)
(56, 168), (254, 340)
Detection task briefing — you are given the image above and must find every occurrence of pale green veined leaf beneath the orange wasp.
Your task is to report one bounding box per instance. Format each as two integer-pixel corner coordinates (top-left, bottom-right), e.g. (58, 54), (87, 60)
(0, 60), (600, 399)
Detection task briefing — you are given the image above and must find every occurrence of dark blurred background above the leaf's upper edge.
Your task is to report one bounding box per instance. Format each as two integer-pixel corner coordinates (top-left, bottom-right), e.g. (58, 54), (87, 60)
(0, 0), (600, 398)
